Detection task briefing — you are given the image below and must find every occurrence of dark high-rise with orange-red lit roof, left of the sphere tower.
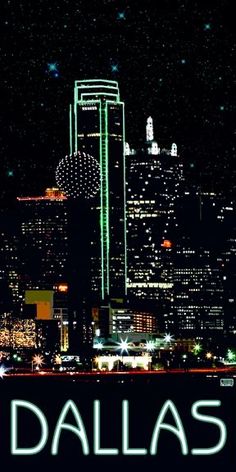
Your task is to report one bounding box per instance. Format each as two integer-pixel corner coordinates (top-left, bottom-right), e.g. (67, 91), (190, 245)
(15, 188), (69, 349)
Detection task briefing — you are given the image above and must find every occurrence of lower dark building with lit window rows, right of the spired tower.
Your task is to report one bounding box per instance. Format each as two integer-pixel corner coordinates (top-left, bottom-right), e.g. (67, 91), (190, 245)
(172, 236), (224, 337)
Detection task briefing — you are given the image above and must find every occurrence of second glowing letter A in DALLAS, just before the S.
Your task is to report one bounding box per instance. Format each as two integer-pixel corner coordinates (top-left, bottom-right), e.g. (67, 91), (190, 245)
(150, 400), (188, 455)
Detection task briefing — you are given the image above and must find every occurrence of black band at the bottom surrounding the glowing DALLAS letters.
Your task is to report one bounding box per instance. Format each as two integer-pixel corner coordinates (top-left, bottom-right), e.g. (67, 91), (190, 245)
(0, 372), (236, 471)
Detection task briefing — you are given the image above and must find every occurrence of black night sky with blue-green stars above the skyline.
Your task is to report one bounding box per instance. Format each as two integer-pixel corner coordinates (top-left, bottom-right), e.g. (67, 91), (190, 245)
(0, 0), (236, 201)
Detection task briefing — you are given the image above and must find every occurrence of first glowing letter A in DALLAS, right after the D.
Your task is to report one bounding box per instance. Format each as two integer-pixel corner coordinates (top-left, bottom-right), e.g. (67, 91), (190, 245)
(51, 400), (89, 456)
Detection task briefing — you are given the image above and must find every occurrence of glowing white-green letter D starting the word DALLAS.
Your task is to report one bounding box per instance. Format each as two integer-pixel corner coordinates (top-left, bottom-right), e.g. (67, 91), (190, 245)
(11, 400), (48, 456)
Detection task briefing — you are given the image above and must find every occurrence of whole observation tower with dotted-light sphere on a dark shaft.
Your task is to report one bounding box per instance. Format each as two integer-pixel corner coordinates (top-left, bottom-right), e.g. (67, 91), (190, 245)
(56, 151), (100, 359)
